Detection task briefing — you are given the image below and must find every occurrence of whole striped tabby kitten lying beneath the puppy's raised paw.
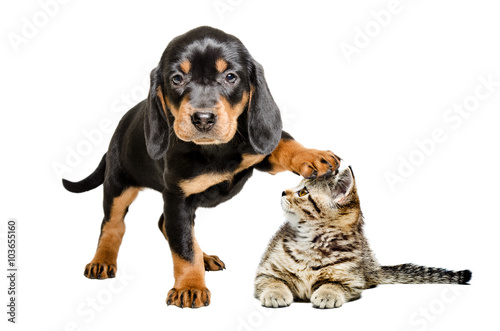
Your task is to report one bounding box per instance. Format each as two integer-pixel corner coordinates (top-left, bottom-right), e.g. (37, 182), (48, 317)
(255, 167), (472, 308)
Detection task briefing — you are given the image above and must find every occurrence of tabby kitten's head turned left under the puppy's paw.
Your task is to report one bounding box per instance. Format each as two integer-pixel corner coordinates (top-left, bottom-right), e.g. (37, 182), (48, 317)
(281, 166), (360, 221)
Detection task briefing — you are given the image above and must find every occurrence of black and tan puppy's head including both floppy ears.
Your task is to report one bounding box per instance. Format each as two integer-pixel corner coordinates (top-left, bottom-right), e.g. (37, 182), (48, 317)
(145, 27), (281, 159)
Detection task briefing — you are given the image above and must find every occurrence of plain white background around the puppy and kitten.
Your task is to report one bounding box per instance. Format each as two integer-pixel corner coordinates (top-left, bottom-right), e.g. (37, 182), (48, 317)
(0, 0), (500, 331)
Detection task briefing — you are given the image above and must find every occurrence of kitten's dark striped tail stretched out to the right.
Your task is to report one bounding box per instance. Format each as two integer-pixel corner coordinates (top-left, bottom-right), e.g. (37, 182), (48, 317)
(378, 263), (472, 284)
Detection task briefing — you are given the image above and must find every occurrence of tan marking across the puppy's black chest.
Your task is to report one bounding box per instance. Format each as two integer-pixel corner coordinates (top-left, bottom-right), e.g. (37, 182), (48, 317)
(179, 154), (265, 197)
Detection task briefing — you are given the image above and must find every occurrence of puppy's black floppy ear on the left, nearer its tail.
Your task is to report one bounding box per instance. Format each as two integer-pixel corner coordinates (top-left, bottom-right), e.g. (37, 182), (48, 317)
(144, 66), (170, 160)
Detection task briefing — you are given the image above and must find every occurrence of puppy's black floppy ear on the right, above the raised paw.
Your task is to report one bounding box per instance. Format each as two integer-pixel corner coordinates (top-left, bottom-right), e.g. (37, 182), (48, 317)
(248, 60), (282, 155)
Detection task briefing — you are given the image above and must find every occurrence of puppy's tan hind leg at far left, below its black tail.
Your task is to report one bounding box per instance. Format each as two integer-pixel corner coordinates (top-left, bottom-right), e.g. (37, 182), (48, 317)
(84, 187), (140, 279)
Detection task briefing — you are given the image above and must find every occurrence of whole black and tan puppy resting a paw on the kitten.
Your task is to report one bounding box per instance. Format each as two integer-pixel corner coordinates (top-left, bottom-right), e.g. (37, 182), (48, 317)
(63, 27), (339, 308)
